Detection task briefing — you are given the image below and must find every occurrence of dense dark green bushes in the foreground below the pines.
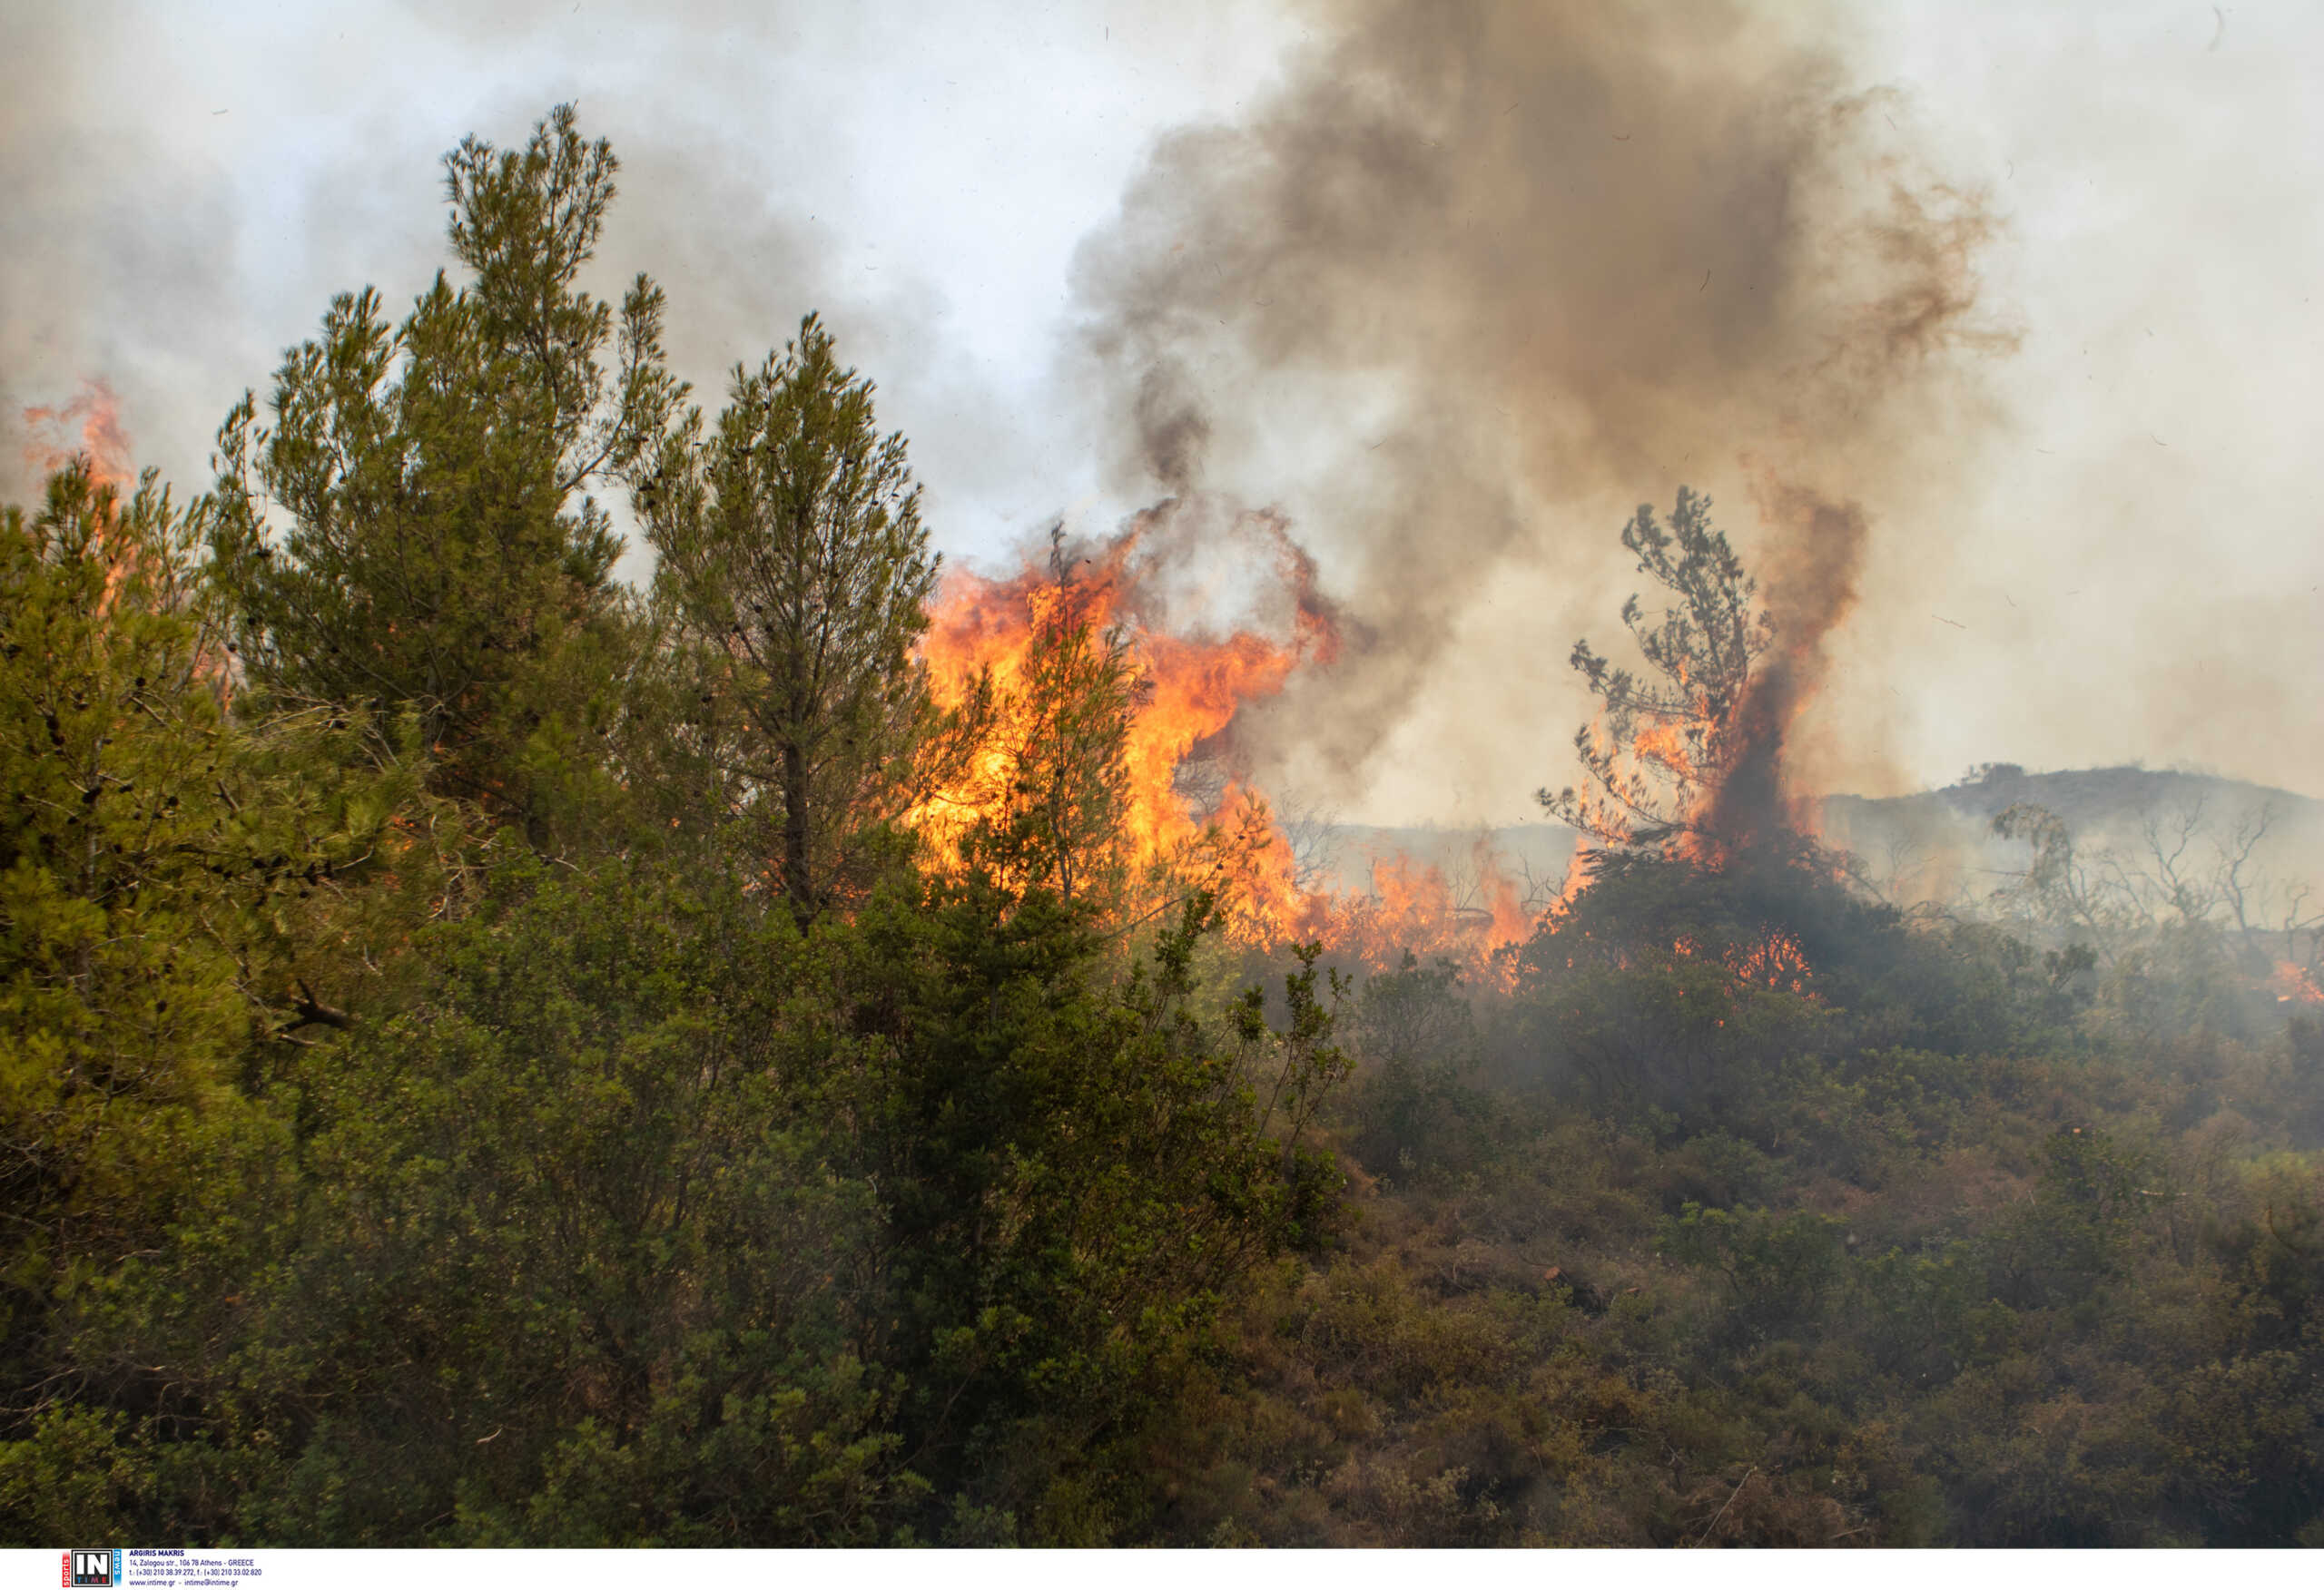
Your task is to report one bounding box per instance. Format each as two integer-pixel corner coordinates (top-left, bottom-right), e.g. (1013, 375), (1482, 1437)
(9, 846), (1339, 1544)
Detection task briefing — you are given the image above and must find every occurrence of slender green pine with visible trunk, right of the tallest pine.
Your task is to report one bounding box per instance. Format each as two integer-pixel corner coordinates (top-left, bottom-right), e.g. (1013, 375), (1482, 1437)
(636, 316), (962, 923)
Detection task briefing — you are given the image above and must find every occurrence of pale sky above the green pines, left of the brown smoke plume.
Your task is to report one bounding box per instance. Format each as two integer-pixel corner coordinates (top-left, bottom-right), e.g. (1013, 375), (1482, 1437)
(0, 0), (1271, 539)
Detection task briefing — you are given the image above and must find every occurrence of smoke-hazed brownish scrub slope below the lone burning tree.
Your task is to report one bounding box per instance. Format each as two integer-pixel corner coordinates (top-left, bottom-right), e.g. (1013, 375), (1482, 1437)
(1171, 813), (2324, 1546)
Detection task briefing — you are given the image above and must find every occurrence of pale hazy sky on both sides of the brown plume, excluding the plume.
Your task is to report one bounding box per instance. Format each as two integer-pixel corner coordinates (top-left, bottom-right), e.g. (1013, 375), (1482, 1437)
(0, 0), (2324, 823)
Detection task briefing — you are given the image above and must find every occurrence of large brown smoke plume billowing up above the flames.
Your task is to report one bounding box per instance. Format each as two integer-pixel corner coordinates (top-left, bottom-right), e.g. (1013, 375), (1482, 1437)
(1078, 0), (2008, 800)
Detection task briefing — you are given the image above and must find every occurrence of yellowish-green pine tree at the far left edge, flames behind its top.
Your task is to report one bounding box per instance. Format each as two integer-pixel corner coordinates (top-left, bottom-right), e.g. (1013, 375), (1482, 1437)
(0, 463), (425, 1450)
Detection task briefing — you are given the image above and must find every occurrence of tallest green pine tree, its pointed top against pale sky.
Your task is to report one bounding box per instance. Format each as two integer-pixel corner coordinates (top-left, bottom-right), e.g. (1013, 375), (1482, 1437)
(214, 107), (685, 837)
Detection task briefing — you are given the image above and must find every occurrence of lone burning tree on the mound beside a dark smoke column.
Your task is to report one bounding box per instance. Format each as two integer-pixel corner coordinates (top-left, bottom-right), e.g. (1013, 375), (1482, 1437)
(1536, 486), (1773, 849)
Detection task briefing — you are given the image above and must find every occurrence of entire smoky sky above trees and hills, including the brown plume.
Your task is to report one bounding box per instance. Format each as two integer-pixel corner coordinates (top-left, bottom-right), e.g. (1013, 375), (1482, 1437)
(0, 0), (2324, 823)
